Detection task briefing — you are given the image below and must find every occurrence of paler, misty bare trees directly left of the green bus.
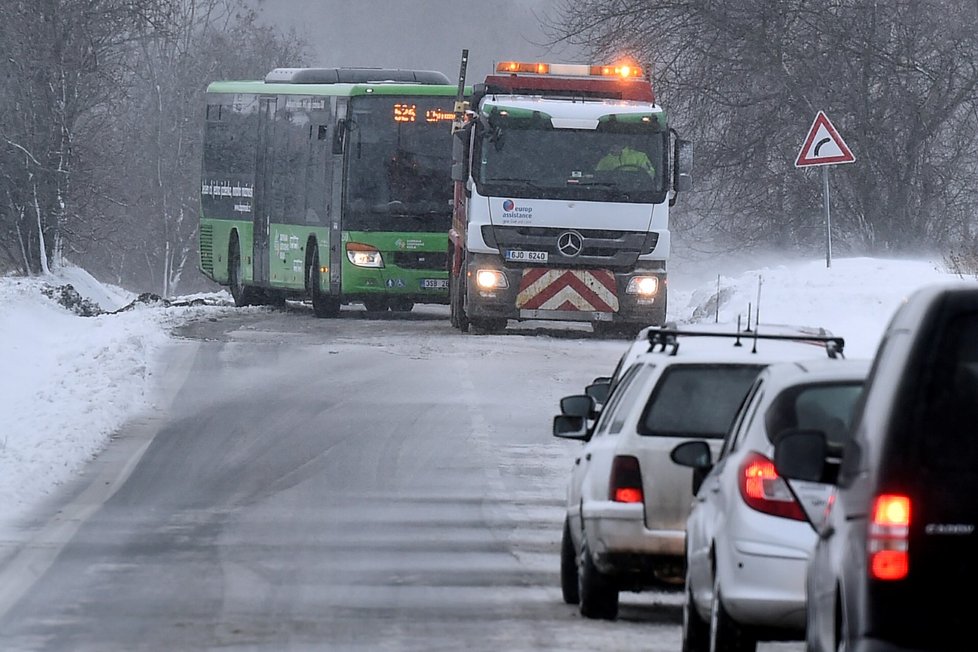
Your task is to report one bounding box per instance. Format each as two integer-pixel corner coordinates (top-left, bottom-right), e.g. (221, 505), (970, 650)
(84, 0), (305, 296)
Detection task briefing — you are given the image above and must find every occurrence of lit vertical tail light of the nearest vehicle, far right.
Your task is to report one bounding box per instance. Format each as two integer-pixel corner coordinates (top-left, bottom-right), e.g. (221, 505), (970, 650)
(866, 494), (910, 580)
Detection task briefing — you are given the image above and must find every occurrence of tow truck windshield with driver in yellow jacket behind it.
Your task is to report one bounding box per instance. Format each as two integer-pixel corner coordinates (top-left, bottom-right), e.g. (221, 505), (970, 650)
(475, 120), (666, 203)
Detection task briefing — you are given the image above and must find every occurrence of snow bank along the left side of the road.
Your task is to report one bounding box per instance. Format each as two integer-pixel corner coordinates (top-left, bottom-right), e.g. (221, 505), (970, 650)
(0, 267), (233, 524)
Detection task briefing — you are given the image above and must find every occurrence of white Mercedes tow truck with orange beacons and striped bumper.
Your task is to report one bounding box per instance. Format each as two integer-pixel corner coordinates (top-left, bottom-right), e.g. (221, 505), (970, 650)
(448, 58), (692, 335)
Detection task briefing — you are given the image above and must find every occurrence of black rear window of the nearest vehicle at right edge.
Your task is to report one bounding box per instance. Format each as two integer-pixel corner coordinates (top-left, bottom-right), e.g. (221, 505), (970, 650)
(916, 313), (978, 473)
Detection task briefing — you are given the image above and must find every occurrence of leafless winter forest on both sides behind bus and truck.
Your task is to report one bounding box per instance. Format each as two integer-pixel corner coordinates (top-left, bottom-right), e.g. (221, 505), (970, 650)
(0, 0), (978, 296)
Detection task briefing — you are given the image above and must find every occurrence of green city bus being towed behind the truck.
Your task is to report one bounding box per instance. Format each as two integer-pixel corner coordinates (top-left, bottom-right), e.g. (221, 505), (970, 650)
(199, 68), (458, 317)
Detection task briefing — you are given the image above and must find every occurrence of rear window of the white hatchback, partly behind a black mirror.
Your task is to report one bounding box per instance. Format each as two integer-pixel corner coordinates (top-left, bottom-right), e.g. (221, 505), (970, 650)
(764, 381), (863, 452)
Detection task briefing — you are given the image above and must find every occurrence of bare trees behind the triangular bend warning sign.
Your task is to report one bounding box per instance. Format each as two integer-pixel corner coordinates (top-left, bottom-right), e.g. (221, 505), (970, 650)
(550, 0), (978, 252)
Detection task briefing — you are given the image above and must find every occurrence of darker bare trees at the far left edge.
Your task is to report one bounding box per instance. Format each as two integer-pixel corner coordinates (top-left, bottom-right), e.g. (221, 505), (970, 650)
(0, 0), (168, 273)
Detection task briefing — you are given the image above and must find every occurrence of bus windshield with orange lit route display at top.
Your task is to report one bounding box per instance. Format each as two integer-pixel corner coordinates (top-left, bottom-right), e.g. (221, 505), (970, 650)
(343, 95), (454, 231)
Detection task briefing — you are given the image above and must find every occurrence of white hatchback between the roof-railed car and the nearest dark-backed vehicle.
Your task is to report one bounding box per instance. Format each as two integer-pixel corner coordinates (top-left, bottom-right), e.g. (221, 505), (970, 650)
(671, 360), (870, 652)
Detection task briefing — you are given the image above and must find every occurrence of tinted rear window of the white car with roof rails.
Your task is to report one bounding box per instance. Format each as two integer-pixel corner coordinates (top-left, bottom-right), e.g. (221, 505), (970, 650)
(639, 364), (763, 439)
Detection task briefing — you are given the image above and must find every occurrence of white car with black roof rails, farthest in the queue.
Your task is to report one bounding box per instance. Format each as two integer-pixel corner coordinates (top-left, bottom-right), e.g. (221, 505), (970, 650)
(554, 328), (844, 619)
